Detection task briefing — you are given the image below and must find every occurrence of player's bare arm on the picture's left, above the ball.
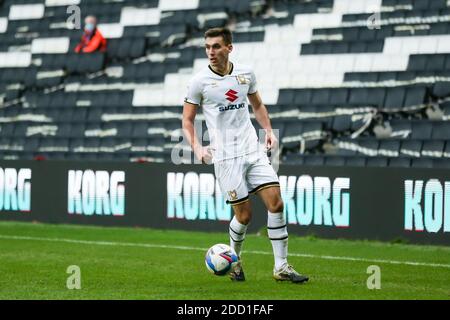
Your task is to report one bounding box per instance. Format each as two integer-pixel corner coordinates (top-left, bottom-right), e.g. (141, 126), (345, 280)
(182, 102), (211, 163)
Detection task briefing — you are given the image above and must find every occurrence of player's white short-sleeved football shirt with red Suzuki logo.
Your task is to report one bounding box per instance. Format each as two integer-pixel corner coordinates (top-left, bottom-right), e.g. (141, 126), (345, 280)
(185, 64), (258, 162)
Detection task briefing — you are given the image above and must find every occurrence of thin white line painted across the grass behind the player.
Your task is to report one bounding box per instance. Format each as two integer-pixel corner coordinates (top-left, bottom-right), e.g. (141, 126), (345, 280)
(0, 234), (450, 269)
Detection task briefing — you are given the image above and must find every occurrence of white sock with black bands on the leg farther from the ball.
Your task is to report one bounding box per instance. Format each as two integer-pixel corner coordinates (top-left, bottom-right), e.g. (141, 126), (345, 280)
(267, 212), (288, 270)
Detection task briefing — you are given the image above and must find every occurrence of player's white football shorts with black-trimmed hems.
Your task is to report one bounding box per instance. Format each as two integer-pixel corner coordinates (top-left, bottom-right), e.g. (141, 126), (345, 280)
(214, 152), (280, 205)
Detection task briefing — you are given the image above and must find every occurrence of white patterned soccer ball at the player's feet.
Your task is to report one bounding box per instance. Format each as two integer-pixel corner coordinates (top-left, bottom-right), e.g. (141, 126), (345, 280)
(205, 243), (238, 276)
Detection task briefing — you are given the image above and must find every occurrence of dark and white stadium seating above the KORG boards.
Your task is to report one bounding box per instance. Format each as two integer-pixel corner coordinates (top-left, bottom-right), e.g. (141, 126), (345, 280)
(0, 0), (450, 168)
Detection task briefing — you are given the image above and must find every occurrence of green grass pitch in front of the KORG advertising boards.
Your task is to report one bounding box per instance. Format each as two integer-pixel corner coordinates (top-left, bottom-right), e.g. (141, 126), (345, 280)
(0, 222), (450, 300)
